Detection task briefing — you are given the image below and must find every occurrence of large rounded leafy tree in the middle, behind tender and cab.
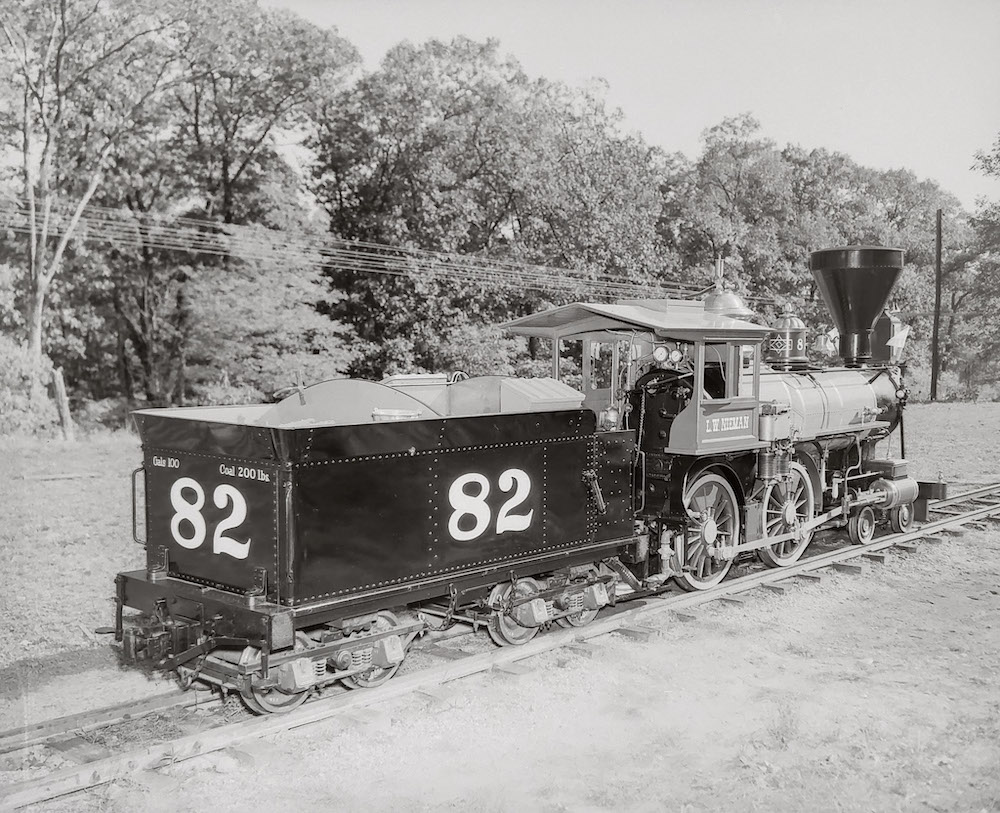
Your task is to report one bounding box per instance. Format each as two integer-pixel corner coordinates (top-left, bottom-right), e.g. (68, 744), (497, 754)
(310, 38), (670, 377)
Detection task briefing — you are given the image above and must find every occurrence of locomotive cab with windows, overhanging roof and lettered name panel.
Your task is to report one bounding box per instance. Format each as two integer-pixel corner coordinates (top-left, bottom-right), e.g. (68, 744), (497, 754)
(504, 300), (768, 455)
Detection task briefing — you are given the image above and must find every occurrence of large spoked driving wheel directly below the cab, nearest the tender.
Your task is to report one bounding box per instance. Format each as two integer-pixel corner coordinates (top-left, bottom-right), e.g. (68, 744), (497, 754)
(674, 473), (740, 591)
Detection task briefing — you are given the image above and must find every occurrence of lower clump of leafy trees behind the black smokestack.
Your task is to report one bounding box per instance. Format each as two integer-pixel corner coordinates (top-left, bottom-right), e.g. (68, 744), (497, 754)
(661, 114), (981, 395)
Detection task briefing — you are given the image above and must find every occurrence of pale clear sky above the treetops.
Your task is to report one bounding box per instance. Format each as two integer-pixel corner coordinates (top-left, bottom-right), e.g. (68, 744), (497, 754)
(264, 0), (1000, 210)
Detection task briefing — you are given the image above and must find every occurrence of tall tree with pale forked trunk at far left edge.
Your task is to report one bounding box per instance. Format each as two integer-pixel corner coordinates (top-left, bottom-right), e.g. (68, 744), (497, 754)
(0, 0), (191, 368)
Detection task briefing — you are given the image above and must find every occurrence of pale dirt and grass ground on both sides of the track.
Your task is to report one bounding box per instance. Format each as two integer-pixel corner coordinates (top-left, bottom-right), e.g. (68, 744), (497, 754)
(0, 404), (1000, 811)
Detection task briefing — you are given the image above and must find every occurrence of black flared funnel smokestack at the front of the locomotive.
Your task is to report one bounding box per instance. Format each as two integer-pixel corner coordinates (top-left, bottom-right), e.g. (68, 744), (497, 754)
(809, 246), (903, 367)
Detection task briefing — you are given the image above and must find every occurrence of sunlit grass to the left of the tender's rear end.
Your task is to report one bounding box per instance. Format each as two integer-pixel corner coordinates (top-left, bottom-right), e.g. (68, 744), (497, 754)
(0, 432), (145, 666)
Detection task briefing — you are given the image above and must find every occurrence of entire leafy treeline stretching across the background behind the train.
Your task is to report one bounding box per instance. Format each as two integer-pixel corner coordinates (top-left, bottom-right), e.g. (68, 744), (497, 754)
(0, 0), (1000, 432)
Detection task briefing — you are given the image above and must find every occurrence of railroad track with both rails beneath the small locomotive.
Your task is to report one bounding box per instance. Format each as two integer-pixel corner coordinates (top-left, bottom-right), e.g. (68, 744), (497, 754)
(0, 483), (1000, 810)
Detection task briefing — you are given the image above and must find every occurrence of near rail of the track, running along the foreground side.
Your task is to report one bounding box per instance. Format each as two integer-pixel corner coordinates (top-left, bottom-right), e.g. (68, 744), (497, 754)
(0, 483), (1000, 810)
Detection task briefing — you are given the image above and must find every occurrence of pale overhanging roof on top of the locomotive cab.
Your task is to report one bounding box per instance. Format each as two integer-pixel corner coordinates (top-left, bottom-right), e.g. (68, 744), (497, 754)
(501, 299), (771, 342)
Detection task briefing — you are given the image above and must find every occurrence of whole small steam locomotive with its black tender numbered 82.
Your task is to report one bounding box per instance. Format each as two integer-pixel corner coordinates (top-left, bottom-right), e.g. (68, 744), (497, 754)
(116, 246), (929, 713)
